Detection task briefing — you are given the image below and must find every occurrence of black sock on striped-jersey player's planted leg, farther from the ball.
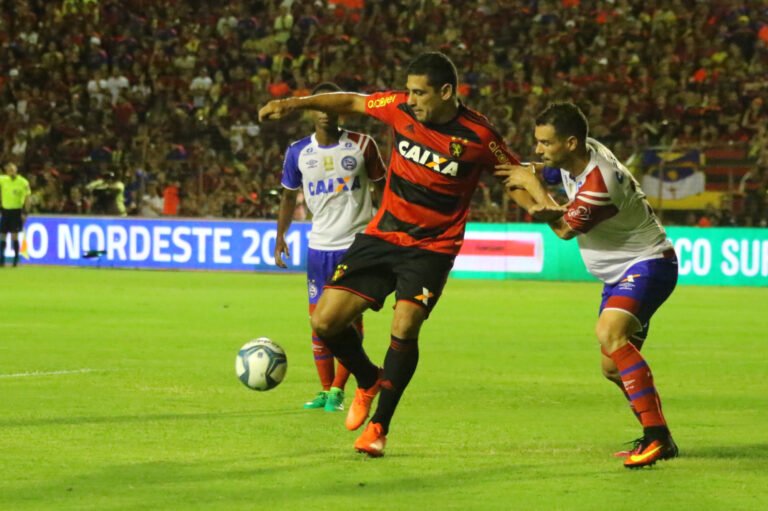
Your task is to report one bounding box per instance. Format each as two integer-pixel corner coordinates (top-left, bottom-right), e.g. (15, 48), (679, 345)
(371, 335), (419, 433)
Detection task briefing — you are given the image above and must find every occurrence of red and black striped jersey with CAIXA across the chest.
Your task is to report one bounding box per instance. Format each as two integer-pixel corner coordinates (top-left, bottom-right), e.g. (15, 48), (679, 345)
(365, 92), (519, 255)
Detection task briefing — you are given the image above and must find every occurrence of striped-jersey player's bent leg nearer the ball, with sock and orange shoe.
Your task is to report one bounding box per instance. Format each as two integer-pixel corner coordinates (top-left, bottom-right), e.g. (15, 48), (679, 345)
(312, 288), (379, 429)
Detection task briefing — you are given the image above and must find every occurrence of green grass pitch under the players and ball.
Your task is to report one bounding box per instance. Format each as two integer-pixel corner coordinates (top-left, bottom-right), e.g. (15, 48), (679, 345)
(0, 267), (768, 511)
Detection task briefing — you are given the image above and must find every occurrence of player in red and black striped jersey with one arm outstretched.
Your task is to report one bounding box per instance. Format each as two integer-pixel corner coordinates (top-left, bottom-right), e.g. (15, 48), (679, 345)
(259, 52), (551, 457)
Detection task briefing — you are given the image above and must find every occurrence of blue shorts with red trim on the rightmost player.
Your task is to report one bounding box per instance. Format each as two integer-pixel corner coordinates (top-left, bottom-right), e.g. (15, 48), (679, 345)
(600, 255), (678, 341)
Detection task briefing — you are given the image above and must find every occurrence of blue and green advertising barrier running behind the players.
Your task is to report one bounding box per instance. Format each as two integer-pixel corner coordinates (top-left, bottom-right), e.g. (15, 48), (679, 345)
(12, 216), (768, 286)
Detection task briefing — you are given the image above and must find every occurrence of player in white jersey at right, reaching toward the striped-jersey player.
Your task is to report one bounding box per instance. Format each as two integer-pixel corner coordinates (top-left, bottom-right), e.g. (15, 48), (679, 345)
(497, 103), (678, 468)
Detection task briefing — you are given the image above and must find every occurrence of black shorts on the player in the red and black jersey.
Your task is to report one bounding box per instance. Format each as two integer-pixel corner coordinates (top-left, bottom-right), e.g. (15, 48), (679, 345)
(326, 234), (456, 314)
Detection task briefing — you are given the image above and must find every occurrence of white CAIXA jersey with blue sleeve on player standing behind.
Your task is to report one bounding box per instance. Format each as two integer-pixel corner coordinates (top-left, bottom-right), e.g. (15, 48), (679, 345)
(281, 130), (385, 250)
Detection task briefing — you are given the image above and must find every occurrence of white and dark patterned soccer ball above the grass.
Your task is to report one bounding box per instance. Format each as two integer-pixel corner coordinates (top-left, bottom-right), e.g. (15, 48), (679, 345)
(235, 337), (288, 390)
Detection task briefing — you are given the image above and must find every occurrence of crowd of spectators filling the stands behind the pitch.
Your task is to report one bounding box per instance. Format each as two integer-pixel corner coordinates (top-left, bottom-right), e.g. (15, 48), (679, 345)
(0, 0), (768, 225)
